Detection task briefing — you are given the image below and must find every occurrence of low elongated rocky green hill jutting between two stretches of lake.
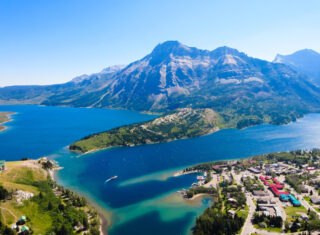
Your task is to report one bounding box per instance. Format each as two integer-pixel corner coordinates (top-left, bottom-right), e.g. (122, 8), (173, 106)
(69, 108), (221, 153)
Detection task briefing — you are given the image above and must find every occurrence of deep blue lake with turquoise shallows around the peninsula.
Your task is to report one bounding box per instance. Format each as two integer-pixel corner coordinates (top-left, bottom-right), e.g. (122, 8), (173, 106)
(0, 106), (320, 234)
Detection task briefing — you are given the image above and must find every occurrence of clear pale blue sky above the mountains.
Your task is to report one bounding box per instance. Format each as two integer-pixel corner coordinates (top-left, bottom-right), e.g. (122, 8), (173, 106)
(0, 0), (320, 86)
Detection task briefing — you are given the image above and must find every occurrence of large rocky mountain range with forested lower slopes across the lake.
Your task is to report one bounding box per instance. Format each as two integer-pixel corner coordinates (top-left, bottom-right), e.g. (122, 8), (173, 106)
(0, 41), (320, 128)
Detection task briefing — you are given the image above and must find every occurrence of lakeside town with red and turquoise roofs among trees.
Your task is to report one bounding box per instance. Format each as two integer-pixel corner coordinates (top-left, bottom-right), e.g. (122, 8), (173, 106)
(181, 149), (320, 235)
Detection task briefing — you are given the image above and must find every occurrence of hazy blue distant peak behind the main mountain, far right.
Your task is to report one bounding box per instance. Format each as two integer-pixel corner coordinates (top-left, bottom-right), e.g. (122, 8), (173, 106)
(273, 49), (320, 85)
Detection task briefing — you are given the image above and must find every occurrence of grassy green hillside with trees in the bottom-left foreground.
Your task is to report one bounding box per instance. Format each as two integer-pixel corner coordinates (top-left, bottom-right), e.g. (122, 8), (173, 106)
(0, 160), (99, 234)
